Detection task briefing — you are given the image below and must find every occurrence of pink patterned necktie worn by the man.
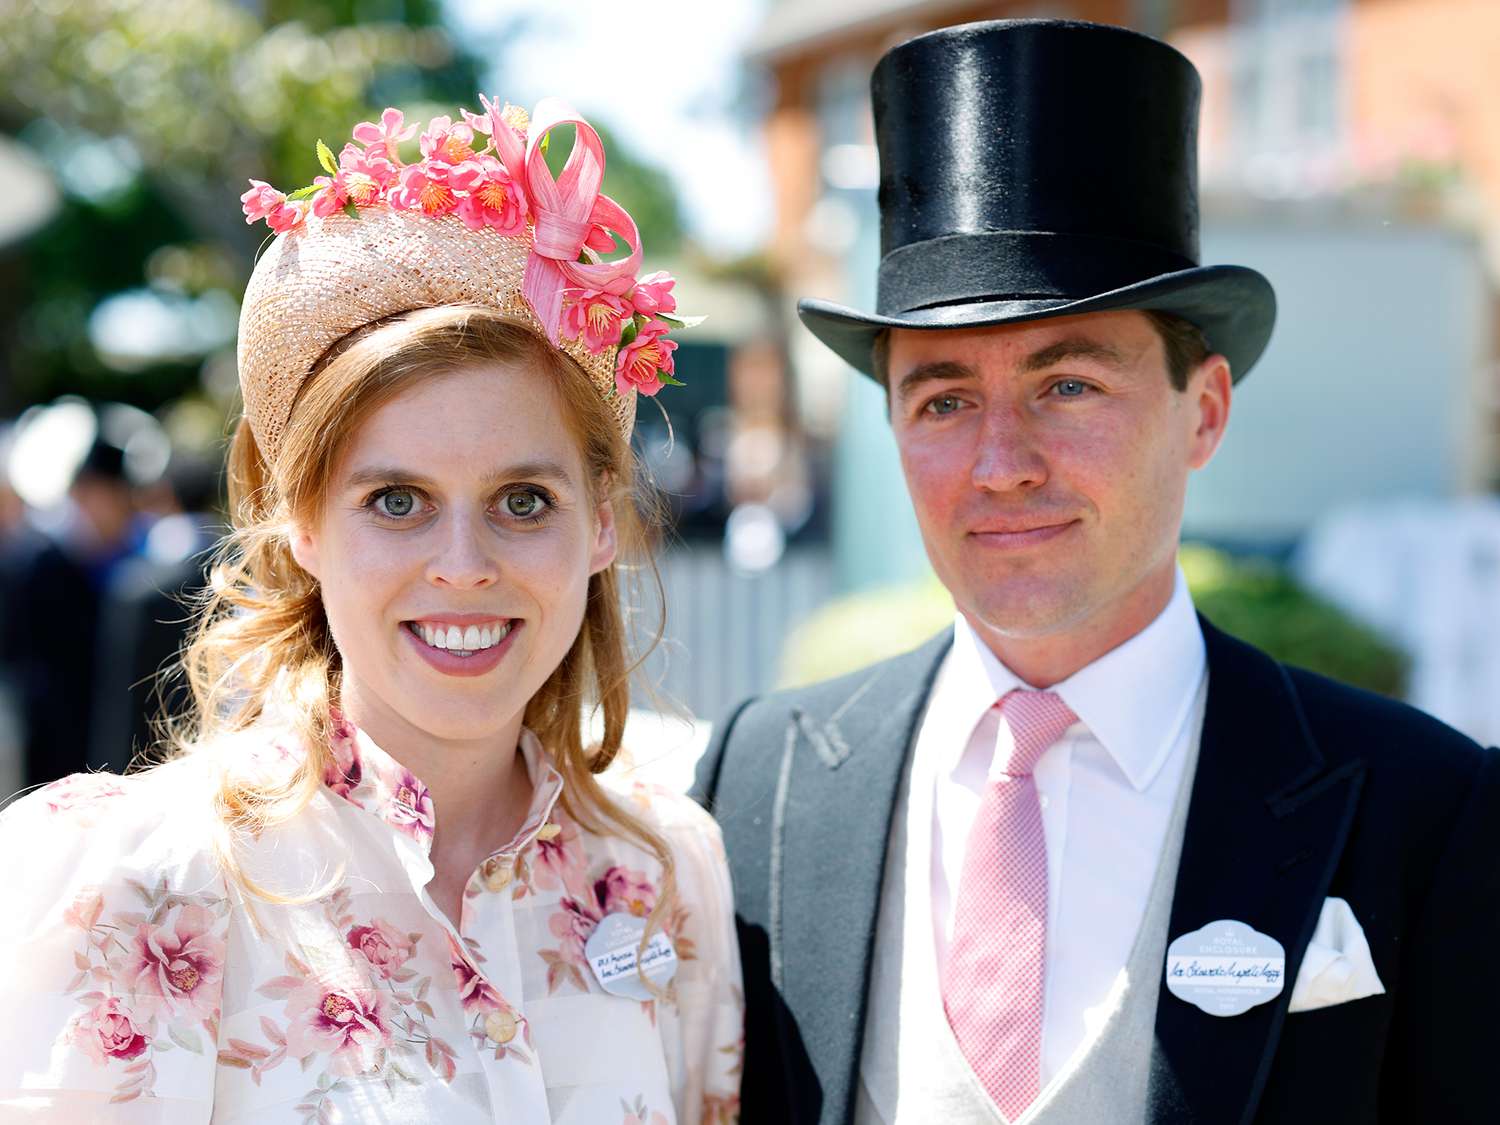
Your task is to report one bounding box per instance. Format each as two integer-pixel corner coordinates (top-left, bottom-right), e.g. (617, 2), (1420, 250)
(942, 692), (1077, 1121)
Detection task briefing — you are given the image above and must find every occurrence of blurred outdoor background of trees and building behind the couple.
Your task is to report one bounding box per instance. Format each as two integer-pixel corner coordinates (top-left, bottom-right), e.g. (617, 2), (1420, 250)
(0, 0), (1500, 795)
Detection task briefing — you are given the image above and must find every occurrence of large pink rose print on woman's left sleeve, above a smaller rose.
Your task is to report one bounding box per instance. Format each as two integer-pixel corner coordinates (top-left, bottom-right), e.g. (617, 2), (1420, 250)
(123, 905), (225, 1020)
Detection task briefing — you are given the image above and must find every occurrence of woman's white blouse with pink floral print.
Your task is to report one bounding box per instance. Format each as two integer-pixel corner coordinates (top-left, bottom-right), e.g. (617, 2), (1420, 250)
(0, 723), (744, 1125)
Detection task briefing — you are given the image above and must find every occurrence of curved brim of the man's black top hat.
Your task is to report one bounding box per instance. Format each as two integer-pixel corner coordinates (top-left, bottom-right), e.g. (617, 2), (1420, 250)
(797, 266), (1277, 383)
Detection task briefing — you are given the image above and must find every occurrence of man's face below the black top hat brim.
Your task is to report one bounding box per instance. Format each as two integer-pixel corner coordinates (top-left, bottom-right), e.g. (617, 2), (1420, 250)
(888, 311), (1230, 644)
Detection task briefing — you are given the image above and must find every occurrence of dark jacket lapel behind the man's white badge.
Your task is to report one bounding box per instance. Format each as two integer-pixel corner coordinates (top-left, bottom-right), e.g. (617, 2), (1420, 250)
(1148, 621), (1364, 1125)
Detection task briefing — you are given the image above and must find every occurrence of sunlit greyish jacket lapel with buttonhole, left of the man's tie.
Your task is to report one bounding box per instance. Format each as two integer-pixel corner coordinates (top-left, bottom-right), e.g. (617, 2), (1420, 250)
(770, 633), (951, 1122)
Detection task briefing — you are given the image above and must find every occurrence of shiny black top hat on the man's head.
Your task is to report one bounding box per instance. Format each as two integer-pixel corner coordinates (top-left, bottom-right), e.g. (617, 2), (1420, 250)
(798, 20), (1277, 380)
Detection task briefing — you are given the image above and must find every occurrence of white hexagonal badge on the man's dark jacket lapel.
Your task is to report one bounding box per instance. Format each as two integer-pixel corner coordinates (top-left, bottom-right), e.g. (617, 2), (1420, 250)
(1167, 918), (1287, 1016)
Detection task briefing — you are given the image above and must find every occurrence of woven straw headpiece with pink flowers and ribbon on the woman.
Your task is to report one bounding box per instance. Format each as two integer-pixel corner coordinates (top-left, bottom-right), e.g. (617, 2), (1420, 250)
(239, 98), (693, 464)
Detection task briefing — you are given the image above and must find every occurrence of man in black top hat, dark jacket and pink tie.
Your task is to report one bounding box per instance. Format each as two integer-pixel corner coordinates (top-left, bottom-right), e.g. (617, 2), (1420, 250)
(698, 21), (1500, 1125)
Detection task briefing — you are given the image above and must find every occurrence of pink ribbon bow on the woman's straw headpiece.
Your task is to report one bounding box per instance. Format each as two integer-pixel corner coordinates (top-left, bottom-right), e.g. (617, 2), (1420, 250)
(522, 98), (641, 345)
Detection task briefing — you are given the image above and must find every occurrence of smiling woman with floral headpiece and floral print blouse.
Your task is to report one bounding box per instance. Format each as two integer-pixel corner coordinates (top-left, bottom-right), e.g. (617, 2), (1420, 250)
(0, 102), (741, 1125)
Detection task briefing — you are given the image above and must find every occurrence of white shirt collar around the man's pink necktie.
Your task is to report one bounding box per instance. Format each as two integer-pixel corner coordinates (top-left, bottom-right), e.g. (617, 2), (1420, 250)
(933, 567), (1208, 792)
